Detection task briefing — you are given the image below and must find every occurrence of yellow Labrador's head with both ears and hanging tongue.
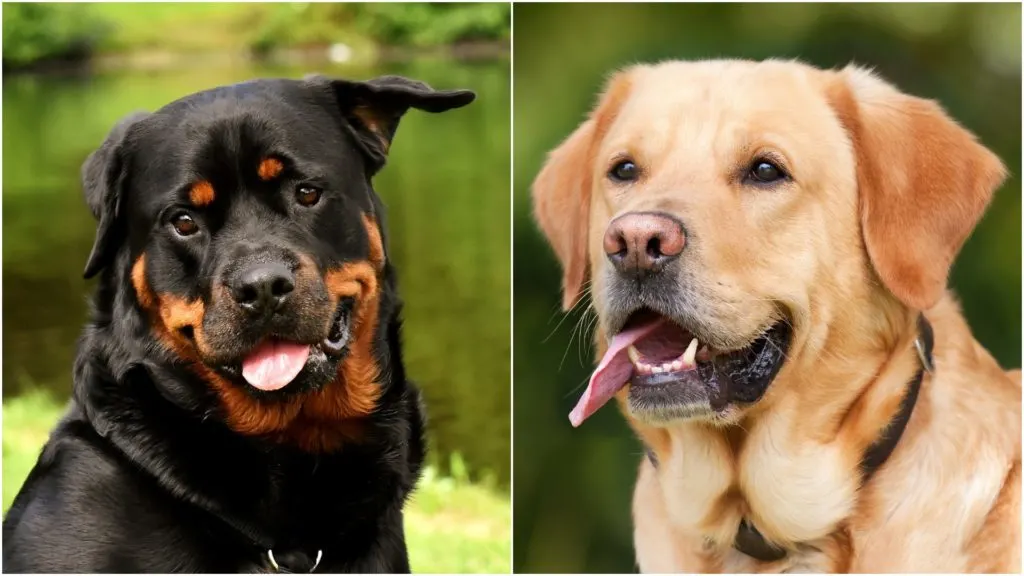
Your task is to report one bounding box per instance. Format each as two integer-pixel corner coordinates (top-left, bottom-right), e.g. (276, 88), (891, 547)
(534, 61), (1004, 425)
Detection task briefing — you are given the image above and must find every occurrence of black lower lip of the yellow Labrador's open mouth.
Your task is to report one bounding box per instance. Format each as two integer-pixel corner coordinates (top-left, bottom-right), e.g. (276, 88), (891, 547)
(629, 320), (793, 417)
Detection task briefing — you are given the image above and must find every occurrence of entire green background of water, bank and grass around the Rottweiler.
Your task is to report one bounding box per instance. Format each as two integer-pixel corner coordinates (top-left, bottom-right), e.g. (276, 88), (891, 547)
(3, 4), (511, 572)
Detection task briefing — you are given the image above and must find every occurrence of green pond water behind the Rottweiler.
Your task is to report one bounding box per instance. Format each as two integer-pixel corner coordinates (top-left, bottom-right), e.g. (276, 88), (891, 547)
(3, 59), (510, 483)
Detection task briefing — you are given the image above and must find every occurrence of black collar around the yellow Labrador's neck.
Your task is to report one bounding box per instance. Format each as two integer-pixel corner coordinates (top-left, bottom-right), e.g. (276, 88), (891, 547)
(732, 315), (935, 562)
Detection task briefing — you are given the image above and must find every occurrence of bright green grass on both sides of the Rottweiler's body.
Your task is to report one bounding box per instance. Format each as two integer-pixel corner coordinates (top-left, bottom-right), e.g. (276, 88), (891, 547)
(3, 392), (511, 573)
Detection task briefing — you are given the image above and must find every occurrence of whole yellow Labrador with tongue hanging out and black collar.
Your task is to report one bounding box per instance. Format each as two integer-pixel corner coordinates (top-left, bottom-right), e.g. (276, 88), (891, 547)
(532, 60), (1021, 573)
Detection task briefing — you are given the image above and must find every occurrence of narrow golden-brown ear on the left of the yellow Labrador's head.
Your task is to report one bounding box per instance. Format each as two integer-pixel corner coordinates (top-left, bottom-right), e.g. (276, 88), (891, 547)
(532, 73), (630, 311)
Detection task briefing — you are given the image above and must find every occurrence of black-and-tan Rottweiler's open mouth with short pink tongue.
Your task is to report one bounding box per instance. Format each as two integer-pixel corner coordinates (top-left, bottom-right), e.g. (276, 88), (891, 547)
(225, 298), (354, 392)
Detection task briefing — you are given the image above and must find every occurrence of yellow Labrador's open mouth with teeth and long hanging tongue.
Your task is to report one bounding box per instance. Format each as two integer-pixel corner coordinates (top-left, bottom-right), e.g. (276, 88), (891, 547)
(569, 310), (792, 426)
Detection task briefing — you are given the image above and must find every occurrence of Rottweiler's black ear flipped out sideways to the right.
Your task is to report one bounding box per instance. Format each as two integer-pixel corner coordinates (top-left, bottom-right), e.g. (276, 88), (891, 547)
(306, 76), (476, 171)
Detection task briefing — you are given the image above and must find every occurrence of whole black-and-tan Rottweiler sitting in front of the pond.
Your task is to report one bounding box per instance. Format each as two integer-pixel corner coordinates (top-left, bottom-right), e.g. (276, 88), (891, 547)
(3, 72), (474, 573)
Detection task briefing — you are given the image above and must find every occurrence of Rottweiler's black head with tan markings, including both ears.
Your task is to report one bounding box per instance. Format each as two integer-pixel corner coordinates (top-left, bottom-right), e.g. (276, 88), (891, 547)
(82, 77), (474, 446)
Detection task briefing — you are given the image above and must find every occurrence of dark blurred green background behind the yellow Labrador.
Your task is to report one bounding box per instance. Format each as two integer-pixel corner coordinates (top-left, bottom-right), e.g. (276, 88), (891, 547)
(513, 4), (1021, 572)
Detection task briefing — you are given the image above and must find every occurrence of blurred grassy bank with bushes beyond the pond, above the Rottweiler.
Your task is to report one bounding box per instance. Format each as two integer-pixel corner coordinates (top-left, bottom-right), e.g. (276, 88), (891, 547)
(3, 2), (511, 67)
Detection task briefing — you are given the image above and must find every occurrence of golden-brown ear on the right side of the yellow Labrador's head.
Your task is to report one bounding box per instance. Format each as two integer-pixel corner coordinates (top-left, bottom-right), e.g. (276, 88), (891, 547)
(829, 67), (1006, 310)
